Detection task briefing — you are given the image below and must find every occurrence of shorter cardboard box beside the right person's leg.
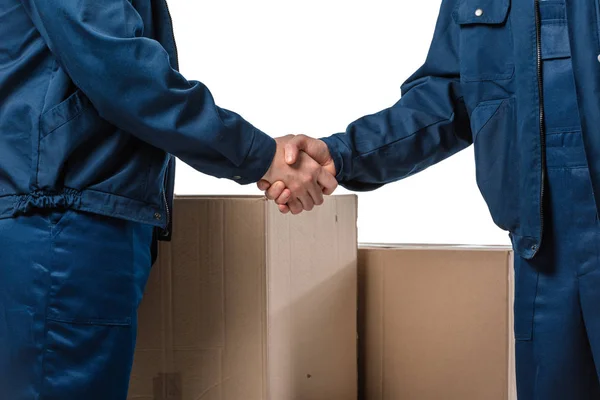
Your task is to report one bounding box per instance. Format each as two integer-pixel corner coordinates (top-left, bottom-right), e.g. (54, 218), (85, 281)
(359, 246), (516, 400)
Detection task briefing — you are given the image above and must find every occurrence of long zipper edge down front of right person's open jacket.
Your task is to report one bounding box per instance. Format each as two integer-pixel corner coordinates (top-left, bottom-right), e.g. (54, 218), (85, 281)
(532, 0), (546, 252)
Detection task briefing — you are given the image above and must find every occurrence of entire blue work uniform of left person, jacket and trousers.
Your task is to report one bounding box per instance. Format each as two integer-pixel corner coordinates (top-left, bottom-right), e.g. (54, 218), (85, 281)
(0, 0), (275, 400)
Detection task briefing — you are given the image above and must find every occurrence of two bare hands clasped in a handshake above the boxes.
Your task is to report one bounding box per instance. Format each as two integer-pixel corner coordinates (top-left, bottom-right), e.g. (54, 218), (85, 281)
(257, 135), (338, 214)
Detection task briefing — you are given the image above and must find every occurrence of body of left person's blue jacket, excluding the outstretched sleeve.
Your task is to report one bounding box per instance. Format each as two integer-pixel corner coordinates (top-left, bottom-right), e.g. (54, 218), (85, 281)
(0, 0), (177, 234)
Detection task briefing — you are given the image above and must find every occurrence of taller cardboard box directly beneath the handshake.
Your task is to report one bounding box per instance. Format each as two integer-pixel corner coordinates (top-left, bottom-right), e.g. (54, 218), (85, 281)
(128, 196), (357, 400)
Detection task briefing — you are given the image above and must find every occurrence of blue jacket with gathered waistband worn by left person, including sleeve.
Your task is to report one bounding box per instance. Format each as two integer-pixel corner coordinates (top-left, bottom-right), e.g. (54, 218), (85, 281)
(0, 0), (275, 241)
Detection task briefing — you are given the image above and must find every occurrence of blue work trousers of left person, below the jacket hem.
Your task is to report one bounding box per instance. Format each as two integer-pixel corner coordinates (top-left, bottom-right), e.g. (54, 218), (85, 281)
(0, 212), (152, 400)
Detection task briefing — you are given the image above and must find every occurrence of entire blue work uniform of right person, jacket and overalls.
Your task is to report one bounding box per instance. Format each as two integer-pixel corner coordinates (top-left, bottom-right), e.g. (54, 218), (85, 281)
(324, 0), (600, 400)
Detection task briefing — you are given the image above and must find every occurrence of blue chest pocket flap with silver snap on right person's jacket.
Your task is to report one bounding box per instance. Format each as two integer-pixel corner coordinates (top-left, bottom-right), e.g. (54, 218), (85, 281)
(453, 0), (510, 25)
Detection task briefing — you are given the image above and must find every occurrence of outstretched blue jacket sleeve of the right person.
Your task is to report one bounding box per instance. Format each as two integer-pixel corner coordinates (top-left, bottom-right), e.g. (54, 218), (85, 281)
(323, 0), (472, 191)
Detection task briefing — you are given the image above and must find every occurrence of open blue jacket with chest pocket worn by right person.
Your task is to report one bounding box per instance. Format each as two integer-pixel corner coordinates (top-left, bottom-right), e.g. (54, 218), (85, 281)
(324, 0), (600, 258)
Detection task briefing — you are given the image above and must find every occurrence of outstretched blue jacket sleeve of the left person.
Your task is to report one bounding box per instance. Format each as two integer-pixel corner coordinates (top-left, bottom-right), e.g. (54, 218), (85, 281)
(21, 0), (275, 184)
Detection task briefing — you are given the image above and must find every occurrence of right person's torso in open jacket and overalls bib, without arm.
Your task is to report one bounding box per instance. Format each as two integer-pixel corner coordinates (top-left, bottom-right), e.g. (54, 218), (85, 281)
(454, 0), (600, 258)
